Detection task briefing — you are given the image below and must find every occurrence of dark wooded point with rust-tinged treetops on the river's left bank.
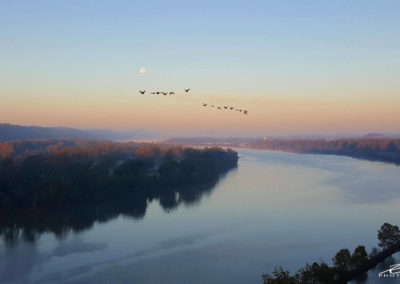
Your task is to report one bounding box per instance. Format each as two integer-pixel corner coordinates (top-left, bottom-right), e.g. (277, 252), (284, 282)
(0, 140), (238, 210)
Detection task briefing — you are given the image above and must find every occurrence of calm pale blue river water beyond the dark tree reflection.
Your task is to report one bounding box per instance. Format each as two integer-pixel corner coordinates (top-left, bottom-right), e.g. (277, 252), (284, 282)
(0, 150), (400, 284)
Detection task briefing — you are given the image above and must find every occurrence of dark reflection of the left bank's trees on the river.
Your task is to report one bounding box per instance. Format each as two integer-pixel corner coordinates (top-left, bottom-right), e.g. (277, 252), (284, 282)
(0, 181), (217, 246)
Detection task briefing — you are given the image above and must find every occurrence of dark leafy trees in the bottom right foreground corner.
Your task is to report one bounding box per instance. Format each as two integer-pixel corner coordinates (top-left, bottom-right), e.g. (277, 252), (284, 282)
(262, 223), (400, 284)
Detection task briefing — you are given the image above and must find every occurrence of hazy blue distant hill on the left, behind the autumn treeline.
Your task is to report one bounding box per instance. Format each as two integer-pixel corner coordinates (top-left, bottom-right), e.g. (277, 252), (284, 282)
(0, 124), (159, 142)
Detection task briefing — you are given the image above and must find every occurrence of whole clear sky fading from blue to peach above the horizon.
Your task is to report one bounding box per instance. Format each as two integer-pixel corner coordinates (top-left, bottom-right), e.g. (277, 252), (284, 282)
(0, 0), (400, 135)
